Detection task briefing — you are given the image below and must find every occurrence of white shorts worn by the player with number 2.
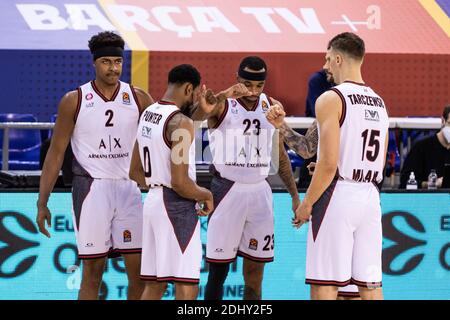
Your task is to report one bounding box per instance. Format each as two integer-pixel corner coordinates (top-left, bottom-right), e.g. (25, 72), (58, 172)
(72, 176), (142, 259)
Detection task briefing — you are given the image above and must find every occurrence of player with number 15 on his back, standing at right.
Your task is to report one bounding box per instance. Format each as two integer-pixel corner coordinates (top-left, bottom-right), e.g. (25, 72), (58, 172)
(268, 32), (389, 299)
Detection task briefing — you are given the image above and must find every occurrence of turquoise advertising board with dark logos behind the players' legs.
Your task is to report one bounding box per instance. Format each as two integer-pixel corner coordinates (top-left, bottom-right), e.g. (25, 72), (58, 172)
(0, 192), (450, 300)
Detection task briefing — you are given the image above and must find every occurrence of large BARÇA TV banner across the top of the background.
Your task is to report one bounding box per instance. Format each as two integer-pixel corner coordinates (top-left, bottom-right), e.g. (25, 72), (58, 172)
(0, 0), (450, 54)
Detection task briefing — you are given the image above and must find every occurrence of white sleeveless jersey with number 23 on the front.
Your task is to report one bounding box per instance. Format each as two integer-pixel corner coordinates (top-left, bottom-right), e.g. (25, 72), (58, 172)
(209, 93), (275, 183)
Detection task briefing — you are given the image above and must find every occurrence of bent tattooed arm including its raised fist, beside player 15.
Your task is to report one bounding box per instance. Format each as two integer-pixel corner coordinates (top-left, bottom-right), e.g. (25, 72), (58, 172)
(266, 98), (319, 159)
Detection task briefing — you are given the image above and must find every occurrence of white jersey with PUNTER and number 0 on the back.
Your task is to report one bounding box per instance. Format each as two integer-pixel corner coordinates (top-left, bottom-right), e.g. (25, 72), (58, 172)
(137, 101), (196, 188)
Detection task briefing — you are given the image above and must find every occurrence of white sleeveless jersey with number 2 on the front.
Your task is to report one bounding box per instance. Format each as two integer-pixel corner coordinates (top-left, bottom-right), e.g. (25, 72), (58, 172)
(71, 81), (139, 179)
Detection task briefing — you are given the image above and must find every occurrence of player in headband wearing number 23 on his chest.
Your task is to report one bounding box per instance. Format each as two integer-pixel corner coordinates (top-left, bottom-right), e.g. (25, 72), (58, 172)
(193, 56), (300, 300)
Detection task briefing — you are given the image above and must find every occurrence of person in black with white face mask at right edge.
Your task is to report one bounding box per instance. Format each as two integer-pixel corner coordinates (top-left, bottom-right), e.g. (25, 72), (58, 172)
(400, 105), (450, 189)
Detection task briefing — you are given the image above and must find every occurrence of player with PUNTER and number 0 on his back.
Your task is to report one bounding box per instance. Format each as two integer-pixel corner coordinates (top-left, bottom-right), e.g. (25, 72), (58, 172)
(130, 64), (213, 300)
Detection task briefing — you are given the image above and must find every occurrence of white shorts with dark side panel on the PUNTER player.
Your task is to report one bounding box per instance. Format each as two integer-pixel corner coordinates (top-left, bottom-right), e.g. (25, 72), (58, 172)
(141, 187), (202, 283)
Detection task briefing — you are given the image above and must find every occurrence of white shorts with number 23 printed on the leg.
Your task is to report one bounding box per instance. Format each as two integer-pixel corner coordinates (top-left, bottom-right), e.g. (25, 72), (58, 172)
(206, 176), (274, 263)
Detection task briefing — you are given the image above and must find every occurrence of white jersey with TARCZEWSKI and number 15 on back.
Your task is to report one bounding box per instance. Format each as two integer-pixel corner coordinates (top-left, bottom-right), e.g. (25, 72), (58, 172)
(318, 82), (389, 183)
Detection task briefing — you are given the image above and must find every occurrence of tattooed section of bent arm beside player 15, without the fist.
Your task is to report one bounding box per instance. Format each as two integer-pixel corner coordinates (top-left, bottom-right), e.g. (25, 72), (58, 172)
(279, 120), (319, 159)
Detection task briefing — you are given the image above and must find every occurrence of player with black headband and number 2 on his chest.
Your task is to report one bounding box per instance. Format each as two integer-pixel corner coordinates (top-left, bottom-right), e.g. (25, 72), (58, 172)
(37, 32), (153, 299)
